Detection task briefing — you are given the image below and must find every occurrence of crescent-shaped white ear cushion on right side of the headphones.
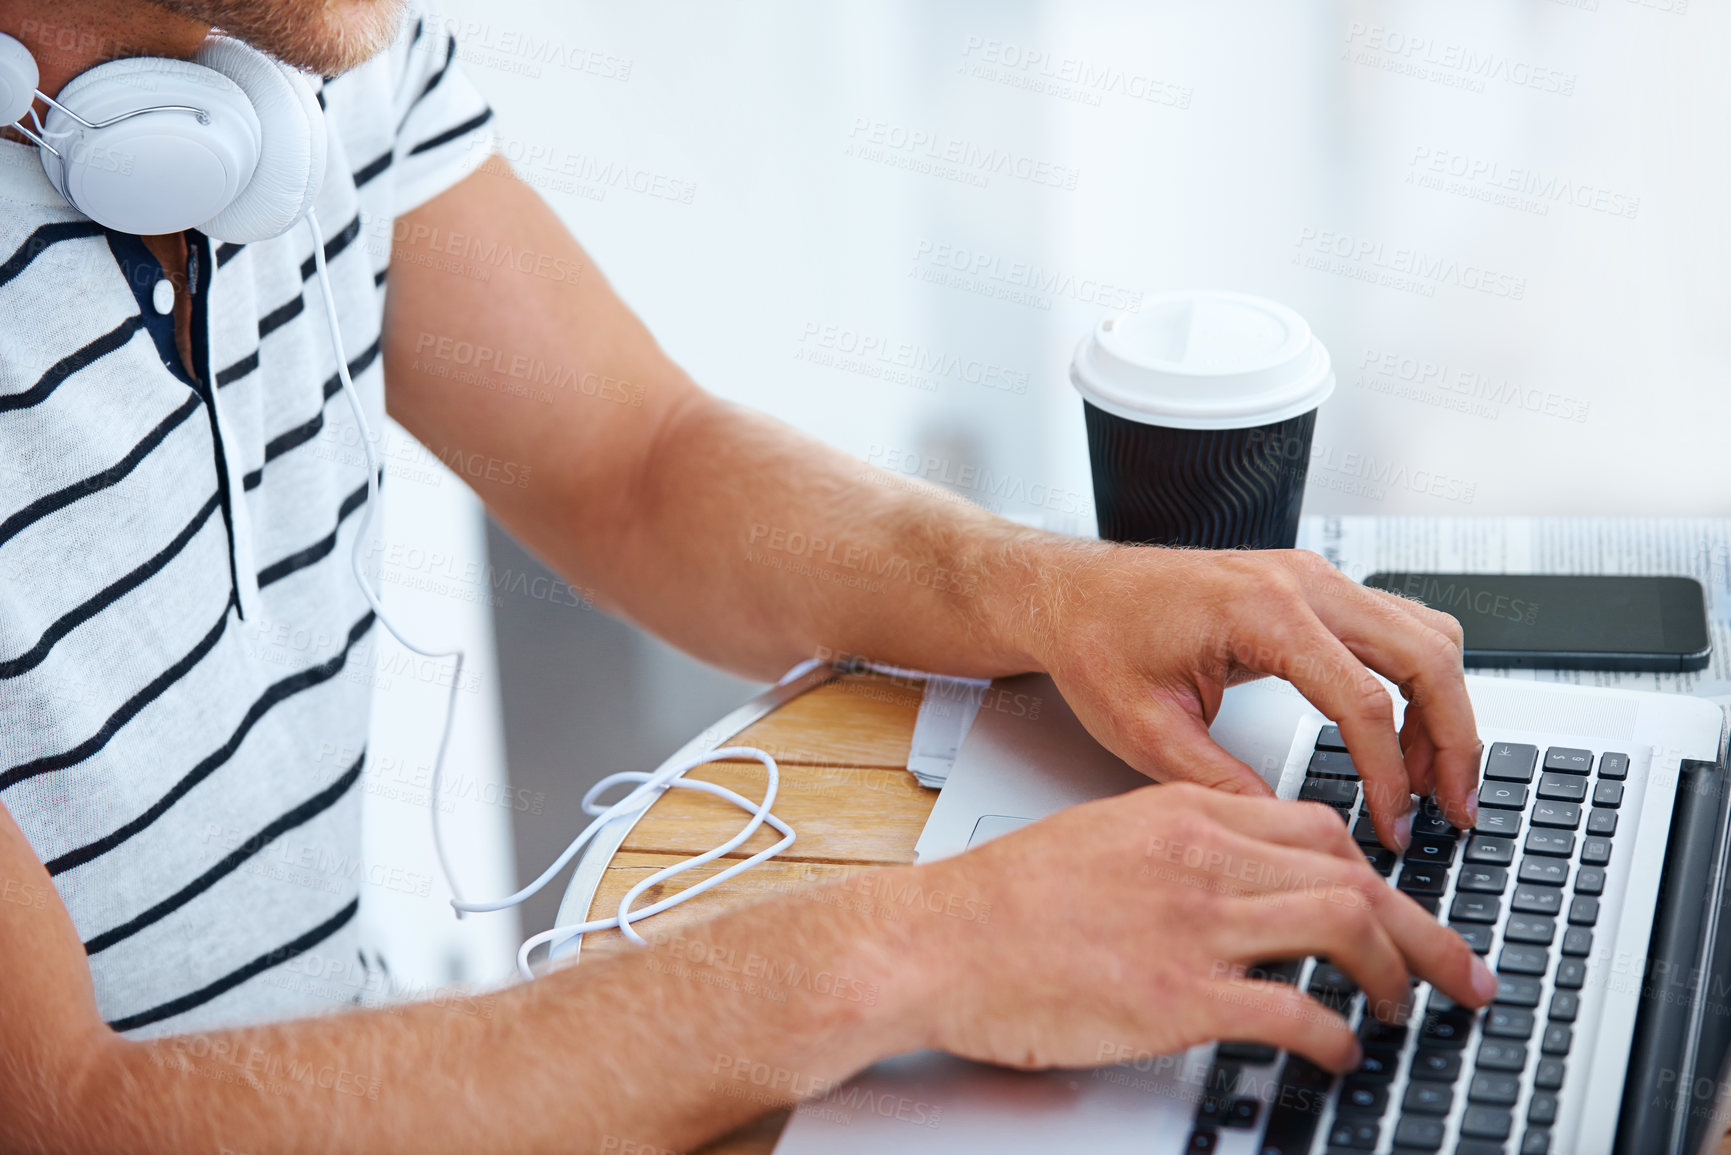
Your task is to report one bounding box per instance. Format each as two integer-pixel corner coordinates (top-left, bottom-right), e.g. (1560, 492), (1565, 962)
(192, 36), (327, 244)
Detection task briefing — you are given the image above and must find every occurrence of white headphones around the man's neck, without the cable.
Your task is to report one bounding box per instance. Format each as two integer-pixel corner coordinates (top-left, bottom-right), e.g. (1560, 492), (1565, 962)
(0, 33), (325, 244)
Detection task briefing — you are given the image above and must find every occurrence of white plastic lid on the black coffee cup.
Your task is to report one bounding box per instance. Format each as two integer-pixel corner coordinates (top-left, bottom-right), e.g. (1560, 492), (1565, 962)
(1070, 289), (1335, 429)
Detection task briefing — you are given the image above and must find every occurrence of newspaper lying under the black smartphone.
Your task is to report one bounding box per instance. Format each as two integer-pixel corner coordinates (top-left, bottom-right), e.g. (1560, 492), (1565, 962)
(1298, 518), (1731, 705)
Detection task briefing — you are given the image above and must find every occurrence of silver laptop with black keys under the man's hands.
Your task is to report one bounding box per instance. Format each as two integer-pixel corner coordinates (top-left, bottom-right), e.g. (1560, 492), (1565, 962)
(775, 675), (1731, 1155)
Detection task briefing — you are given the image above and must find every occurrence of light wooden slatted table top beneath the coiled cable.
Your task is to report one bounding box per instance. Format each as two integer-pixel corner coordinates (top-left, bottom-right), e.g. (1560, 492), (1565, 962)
(580, 674), (938, 1155)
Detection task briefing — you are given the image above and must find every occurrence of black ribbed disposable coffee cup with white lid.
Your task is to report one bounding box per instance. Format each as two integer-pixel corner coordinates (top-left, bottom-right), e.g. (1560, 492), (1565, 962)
(1070, 291), (1335, 549)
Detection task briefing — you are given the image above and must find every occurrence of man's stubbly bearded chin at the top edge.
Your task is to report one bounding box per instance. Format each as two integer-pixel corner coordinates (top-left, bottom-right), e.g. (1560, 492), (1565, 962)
(149, 0), (405, 76)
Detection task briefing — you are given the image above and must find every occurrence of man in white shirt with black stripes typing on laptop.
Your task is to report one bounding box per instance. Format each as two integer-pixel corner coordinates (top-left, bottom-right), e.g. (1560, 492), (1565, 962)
(0, 0), (1496, 1152)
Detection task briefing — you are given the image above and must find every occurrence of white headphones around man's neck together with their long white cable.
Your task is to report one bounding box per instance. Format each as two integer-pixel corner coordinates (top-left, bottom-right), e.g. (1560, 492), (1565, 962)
(0, 33), (817, 978)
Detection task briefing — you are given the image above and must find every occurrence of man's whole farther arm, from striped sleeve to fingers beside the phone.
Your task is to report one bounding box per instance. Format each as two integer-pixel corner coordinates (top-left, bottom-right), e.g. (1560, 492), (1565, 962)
(384, 158), (1478, 847)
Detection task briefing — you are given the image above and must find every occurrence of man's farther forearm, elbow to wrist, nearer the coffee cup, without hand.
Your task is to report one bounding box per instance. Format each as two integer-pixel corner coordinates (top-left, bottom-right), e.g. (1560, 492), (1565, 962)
(553, 398), (1108, 677)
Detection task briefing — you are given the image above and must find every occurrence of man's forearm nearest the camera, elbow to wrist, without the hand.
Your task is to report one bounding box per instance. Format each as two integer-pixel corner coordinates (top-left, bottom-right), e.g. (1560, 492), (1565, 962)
(20, 872), (926, 1153)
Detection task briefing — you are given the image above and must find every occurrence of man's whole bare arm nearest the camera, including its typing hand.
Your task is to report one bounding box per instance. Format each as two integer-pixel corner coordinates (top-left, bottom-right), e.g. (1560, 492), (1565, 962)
(0, 784), (1496, 1155)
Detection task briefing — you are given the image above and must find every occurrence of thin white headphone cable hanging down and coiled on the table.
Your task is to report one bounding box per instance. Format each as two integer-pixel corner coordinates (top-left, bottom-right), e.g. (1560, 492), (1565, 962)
(306, 210), (795, 978)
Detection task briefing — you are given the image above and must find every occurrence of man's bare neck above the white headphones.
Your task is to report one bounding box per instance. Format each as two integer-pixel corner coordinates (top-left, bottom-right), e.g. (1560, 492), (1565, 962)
(0, 0), (209, 97)
